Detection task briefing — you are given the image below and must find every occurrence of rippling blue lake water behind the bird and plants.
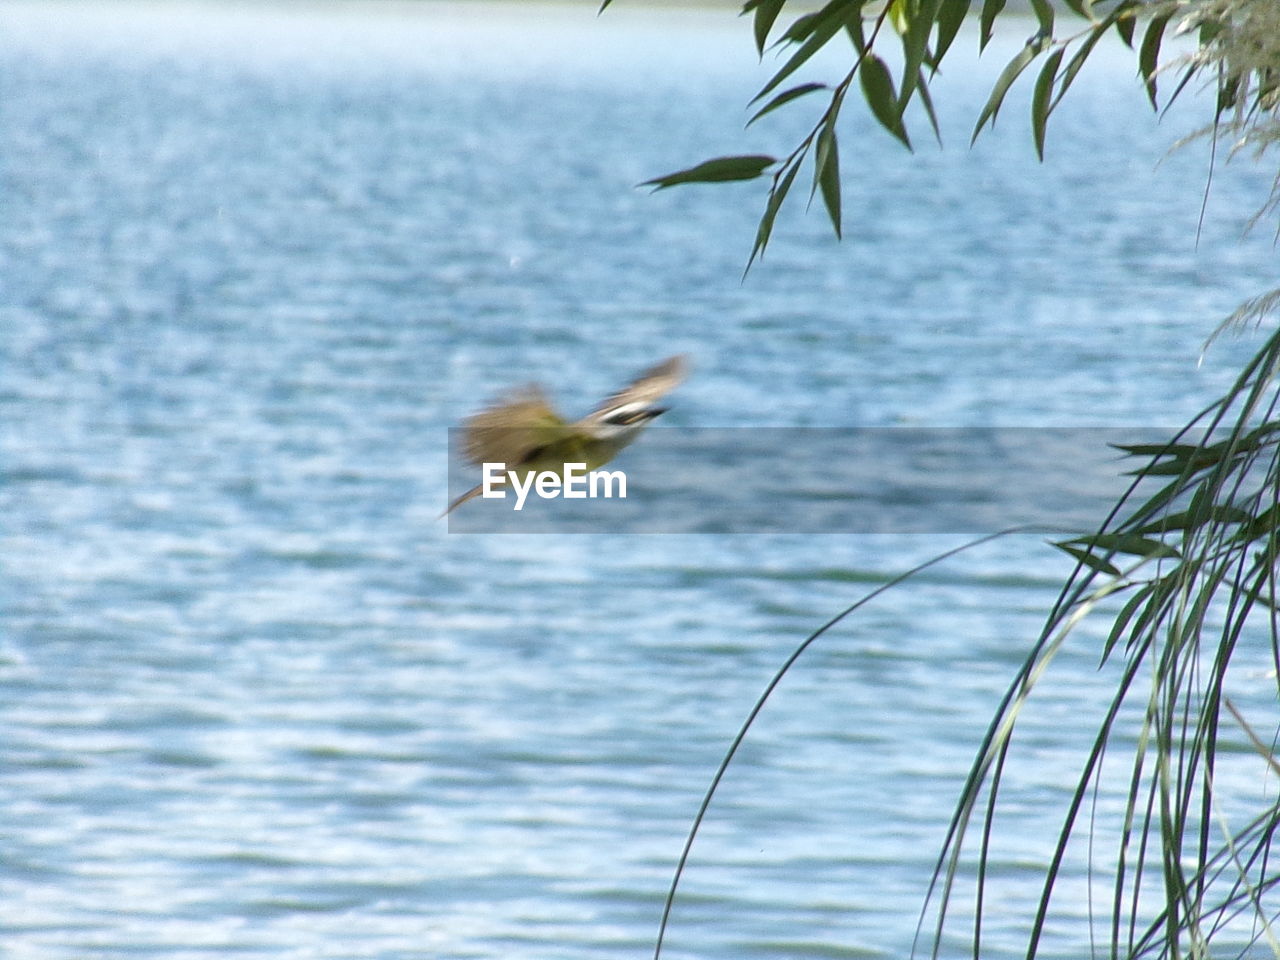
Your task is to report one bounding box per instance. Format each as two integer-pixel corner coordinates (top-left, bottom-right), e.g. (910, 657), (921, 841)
(0, 0), (1274, 960)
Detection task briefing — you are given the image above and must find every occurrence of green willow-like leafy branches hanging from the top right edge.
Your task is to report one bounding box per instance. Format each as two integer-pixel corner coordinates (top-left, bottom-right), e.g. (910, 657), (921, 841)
(637, 0), (1280, 269)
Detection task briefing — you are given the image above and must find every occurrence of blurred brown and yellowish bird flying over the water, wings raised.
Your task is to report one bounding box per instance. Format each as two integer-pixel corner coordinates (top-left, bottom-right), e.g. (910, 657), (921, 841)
(440, 356), (689, 517)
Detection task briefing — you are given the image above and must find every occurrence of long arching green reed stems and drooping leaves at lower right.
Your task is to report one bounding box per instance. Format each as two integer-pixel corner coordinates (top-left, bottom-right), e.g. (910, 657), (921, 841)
(654, 332), (1280, 960)
